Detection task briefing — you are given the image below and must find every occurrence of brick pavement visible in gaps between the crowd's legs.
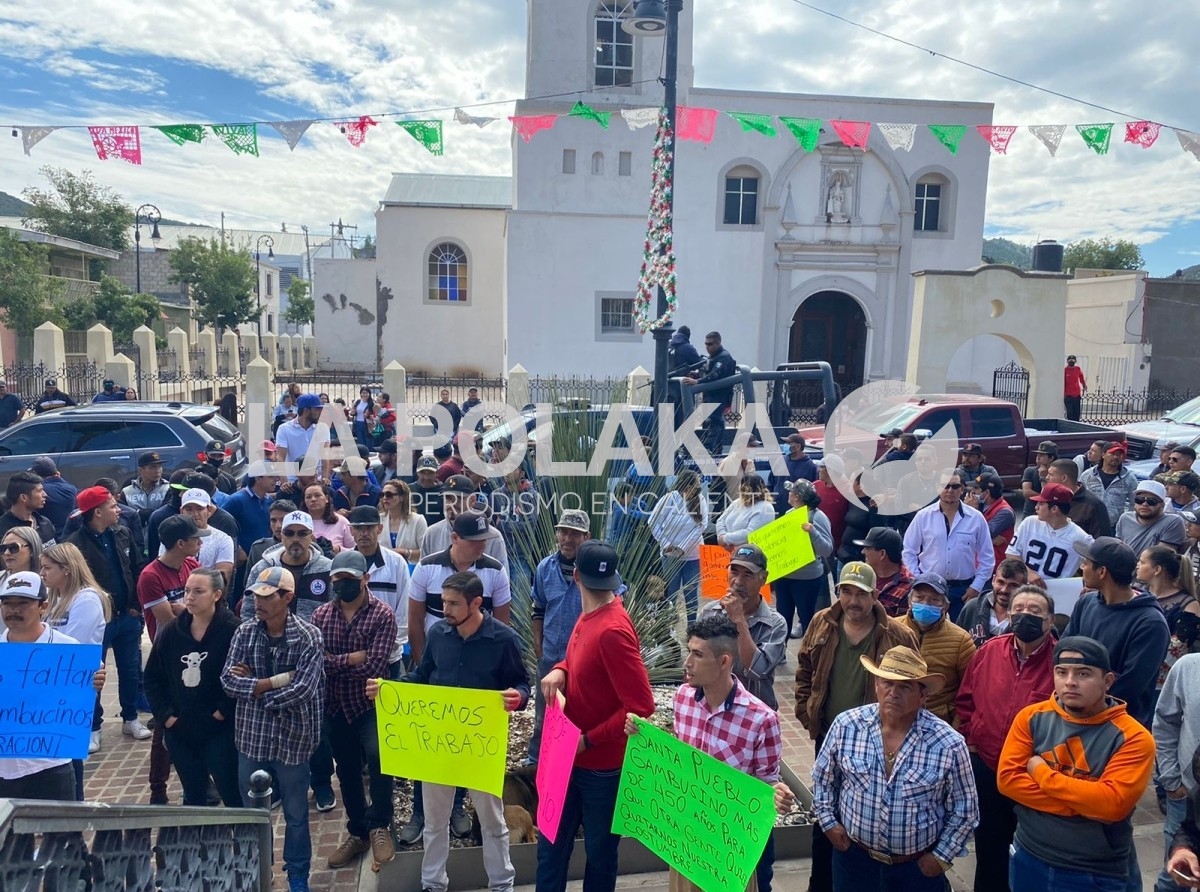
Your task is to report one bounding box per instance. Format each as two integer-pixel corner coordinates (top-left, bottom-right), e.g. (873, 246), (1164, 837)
(84, 642), (1163, 892)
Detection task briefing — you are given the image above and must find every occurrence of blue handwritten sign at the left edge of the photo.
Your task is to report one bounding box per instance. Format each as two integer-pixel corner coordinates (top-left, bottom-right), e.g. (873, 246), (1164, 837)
(0, 641), (100, 759)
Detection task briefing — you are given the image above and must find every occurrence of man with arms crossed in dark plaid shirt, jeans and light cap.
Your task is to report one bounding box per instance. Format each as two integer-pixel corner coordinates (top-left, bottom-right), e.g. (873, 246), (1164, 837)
(221, 567), (325, 892)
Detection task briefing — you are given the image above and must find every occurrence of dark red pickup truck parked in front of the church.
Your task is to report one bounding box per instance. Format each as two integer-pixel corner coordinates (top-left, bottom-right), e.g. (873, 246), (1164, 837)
(799, 394), (1126, 490)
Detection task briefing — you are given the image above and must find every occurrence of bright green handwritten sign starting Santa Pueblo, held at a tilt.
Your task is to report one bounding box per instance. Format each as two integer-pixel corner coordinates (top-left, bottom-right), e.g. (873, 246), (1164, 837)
(612, 719), (775, 892)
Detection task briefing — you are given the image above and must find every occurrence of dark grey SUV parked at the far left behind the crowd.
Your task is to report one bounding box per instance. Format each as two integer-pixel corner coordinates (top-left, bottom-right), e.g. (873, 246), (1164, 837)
(0, 401), (246, 489)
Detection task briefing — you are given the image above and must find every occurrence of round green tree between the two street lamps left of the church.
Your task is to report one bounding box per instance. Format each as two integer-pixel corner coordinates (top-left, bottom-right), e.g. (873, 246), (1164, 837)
(169, 238), (259, 329)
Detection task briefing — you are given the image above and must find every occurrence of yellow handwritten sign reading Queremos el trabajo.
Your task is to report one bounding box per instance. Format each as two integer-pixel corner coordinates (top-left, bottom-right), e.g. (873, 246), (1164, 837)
(376, 682), (509, 796)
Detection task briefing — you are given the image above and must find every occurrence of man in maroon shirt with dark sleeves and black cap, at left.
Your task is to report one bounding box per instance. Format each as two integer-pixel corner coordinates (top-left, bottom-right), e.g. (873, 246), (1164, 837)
(138, 514), (200, 806)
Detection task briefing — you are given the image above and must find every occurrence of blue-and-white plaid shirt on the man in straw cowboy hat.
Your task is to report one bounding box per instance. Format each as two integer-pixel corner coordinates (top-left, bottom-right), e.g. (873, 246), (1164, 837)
(812, 704), (979, 861)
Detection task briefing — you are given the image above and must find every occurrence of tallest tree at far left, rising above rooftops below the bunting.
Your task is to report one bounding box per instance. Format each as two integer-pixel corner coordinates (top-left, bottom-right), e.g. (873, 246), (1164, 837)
(22, 167), (133, 251)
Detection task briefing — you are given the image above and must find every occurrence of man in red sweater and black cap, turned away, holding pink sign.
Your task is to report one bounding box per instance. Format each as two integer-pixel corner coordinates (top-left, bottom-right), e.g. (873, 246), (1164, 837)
(536, 539), (654, 892)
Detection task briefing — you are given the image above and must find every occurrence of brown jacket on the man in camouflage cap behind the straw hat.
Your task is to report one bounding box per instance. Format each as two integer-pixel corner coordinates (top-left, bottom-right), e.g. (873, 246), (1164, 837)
(796, 601), (919, 741)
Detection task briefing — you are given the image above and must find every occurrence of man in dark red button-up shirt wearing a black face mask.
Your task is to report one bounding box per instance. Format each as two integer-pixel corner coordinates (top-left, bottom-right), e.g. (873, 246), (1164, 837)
(954, 586), (1055, 892)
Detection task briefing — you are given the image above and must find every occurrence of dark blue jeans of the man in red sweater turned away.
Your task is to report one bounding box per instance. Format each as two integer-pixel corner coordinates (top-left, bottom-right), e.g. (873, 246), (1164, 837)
(535, 768), (620, 892)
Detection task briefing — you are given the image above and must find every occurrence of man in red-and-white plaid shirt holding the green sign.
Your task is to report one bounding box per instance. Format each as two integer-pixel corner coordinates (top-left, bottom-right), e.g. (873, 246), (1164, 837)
(625, 613), (784, 892)
